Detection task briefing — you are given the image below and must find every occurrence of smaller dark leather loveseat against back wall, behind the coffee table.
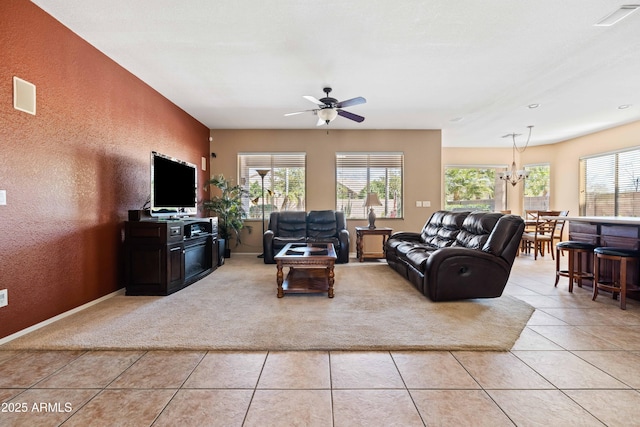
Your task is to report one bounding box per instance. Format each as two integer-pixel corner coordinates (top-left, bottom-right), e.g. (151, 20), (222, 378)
(262, 210), (349, 264)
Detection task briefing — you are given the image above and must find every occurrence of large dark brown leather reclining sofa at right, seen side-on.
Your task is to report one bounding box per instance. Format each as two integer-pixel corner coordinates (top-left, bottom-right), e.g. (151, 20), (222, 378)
(385, 211), (524, 301)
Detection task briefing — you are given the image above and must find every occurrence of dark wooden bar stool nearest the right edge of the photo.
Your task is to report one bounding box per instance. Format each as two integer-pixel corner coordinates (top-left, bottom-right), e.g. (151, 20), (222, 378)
(592, 247), (640, 310)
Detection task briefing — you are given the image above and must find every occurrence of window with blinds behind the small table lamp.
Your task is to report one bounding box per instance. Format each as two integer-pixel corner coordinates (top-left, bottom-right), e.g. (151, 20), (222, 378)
(336, 152), (404, 219)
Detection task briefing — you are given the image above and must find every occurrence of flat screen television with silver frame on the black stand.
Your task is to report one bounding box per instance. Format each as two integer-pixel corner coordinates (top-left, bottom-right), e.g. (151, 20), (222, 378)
(150, 151), (198, 218)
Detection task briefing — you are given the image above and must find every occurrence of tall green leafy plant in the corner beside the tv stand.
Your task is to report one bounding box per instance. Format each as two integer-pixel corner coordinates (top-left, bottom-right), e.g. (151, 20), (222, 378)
(202, 175), (251, 258)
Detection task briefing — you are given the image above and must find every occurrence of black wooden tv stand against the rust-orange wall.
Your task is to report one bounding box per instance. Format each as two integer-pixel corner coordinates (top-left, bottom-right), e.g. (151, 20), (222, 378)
(124, 218), (218, 295)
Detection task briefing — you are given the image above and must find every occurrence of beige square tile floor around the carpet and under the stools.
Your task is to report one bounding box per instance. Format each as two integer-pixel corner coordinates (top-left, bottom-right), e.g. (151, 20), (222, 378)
(0, 255), (640, 427)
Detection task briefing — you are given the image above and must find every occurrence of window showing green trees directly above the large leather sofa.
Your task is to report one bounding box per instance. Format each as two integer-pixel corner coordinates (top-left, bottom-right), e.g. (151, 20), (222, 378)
(444, 166), (507, 212)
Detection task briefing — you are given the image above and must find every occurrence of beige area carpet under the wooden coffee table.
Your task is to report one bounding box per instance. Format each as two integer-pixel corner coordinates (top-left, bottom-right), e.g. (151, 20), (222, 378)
(0, 255), (534, 350)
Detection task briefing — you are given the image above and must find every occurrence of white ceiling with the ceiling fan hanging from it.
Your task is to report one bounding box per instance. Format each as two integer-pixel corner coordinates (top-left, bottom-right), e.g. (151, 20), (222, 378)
(33, 0), (640, 147)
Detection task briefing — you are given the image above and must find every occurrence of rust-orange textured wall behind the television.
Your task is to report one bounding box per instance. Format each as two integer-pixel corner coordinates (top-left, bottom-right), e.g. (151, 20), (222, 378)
(0, 0), (209, 338)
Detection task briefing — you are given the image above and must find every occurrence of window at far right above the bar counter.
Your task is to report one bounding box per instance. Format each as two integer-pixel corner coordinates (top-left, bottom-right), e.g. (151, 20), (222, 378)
(580, 148), (640, 217)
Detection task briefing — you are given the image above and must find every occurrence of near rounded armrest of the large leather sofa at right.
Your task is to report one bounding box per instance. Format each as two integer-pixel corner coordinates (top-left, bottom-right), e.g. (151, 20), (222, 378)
(424, 247), (511, 301)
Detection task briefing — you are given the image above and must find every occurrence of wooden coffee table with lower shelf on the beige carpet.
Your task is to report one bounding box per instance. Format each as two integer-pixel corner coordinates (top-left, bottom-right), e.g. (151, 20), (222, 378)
(274, 243), (338, 298)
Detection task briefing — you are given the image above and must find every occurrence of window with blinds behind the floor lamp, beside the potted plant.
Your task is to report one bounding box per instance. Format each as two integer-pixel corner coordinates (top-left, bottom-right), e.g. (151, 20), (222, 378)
(238, 153), (307, 219)
